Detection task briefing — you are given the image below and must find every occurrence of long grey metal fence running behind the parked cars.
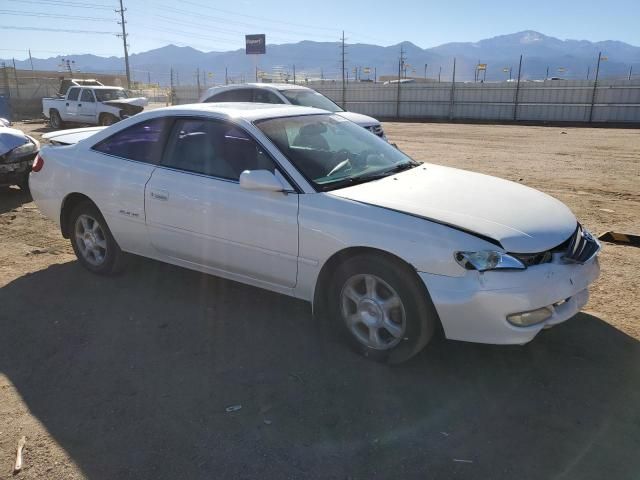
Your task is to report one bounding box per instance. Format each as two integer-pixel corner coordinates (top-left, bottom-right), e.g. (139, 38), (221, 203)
(174, 79), (640, 124)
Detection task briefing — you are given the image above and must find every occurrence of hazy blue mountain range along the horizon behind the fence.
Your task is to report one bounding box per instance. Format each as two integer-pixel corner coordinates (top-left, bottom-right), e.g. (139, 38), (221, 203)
(5, 30), (640, 85)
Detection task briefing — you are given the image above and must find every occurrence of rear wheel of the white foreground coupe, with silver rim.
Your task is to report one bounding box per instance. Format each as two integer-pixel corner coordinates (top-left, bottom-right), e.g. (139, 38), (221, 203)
(68, 202), (124, 275)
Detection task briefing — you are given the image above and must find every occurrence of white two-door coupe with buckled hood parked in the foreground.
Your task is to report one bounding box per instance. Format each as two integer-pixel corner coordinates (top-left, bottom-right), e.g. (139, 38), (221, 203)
(30, 103), (600, 363)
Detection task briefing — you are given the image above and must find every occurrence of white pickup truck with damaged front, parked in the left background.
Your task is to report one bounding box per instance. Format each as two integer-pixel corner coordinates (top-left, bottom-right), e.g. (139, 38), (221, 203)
(42, 86), (148, 130)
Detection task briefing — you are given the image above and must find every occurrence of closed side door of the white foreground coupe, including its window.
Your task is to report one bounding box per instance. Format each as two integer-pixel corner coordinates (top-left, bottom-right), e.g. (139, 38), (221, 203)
(145, 118), (298, 287)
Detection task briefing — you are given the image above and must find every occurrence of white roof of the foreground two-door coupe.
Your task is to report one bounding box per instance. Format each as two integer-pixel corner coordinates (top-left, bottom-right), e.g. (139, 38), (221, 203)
(142, 102), (331, 122)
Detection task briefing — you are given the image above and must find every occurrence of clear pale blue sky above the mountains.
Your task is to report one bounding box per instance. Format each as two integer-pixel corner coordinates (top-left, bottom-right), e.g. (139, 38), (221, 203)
(0, 0), (640, 59)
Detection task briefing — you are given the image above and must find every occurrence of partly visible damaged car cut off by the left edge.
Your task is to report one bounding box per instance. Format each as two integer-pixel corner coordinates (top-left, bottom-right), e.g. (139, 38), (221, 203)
(0, 118), (40, 190)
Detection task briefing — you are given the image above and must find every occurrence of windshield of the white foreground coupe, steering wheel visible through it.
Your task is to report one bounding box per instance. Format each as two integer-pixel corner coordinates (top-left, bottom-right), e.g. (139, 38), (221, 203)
(256, 115), (417, 191)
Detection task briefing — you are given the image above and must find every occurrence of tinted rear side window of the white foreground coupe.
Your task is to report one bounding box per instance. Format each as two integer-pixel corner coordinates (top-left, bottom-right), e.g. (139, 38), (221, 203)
(92, 118), (171, 164)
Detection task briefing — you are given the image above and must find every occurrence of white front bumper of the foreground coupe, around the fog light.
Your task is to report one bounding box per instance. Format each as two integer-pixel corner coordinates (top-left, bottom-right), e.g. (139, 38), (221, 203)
(419, 257), (600, 344)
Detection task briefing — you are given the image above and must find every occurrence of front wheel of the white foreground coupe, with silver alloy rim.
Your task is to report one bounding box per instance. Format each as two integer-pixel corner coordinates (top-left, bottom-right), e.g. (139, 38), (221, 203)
(329, 254), (438, 364)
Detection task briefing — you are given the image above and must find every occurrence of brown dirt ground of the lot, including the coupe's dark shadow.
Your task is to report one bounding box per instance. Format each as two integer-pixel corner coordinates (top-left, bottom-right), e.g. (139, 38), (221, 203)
(0, 117), (640, 480)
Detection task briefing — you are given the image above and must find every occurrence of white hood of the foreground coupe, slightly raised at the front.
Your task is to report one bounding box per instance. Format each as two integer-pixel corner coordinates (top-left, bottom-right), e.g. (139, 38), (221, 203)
(331, 164), (577, 253)
